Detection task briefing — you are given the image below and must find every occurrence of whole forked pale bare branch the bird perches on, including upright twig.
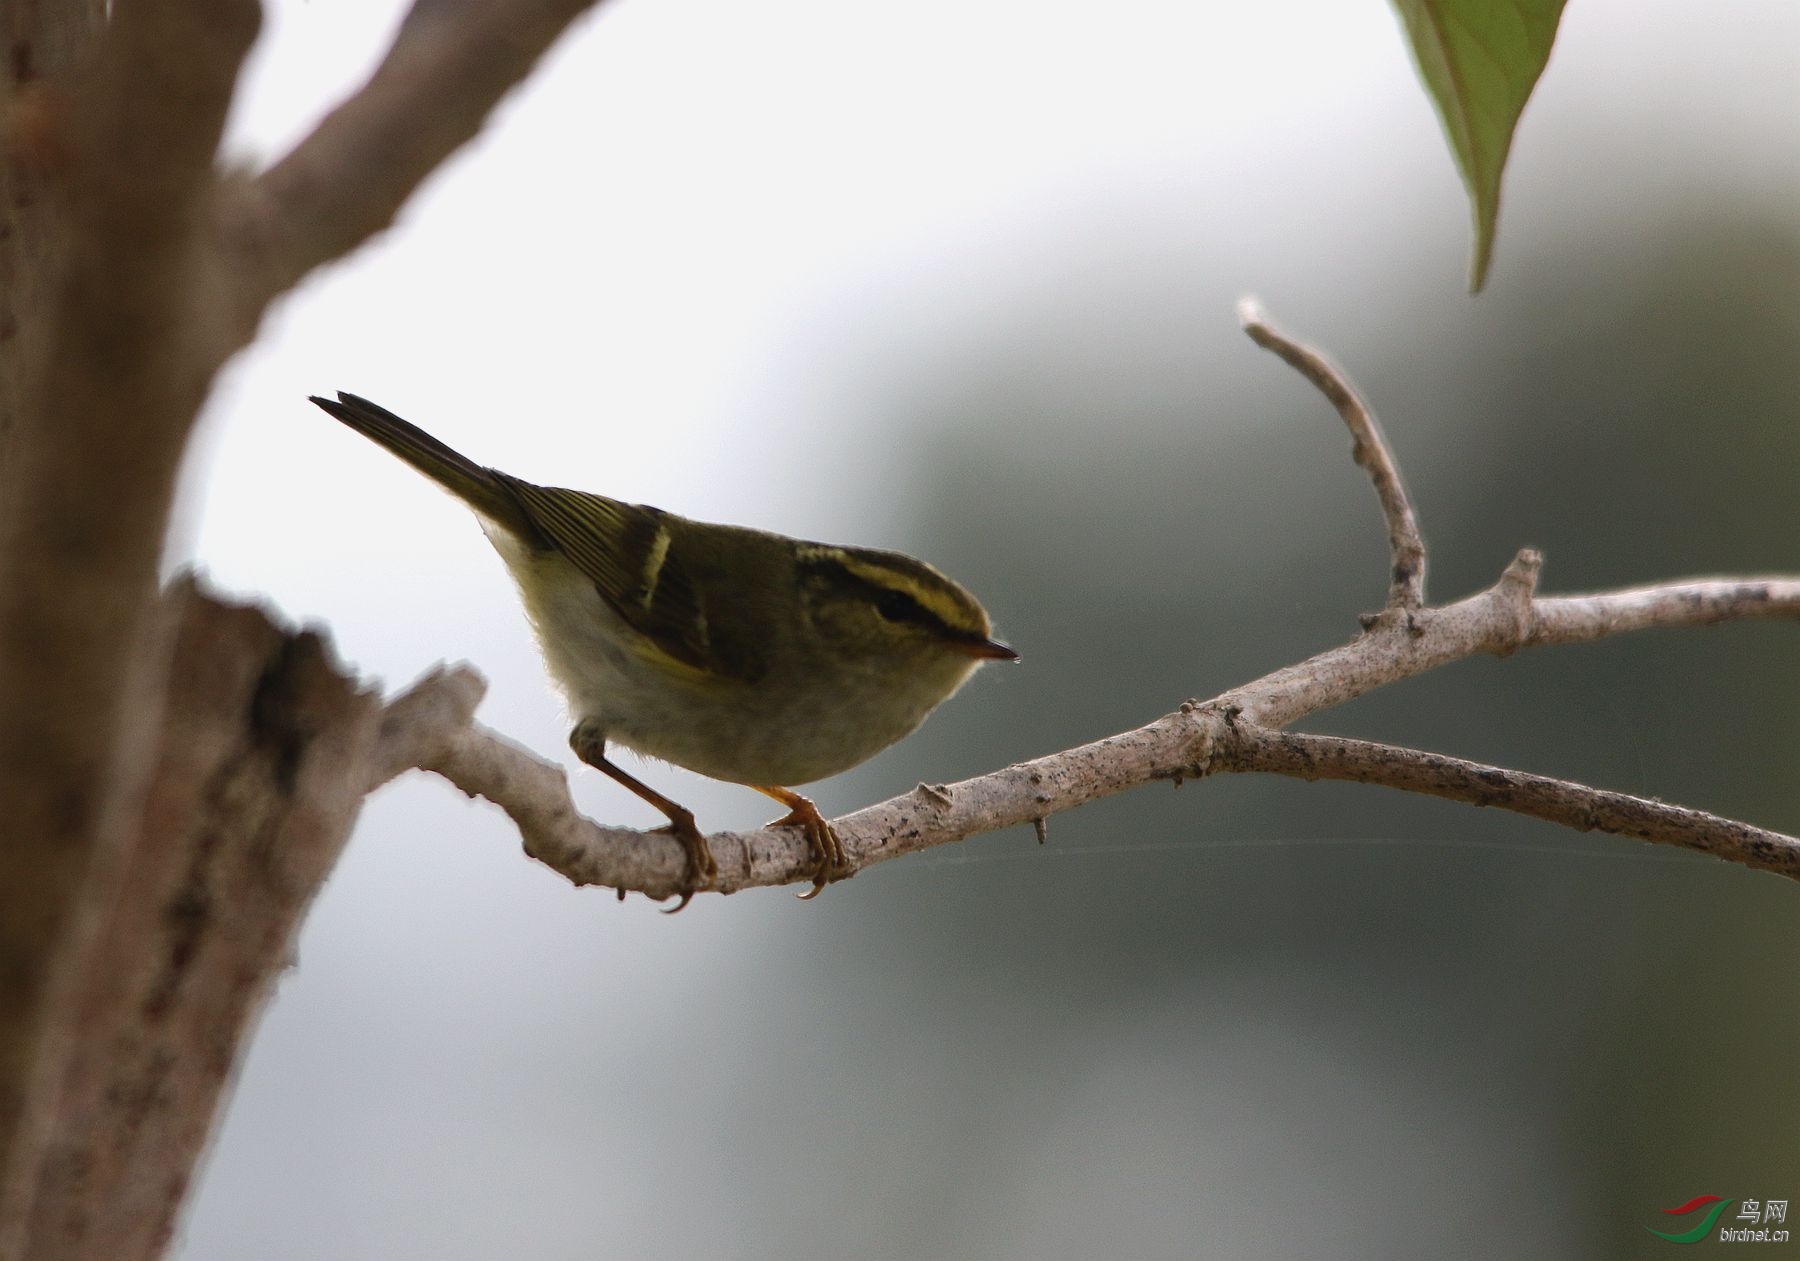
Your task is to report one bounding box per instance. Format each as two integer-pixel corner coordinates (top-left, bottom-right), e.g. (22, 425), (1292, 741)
(371, 302), (1800, 898)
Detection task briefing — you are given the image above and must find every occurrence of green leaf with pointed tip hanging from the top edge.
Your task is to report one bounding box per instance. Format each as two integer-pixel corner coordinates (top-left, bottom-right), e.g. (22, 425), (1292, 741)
(1393, 0), (1562, 290)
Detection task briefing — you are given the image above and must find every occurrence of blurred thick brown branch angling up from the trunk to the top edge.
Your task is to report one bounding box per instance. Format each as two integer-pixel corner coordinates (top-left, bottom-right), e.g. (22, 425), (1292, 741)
(223, 0), (615, 313)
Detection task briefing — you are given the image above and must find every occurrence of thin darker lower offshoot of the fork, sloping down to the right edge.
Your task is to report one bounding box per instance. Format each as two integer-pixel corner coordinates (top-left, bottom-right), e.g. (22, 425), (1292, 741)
(1219, 725), (1800, 880)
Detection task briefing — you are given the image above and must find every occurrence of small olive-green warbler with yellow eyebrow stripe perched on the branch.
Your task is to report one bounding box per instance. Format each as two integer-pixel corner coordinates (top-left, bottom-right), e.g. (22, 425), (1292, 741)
(311, 394), (1019, 910)
